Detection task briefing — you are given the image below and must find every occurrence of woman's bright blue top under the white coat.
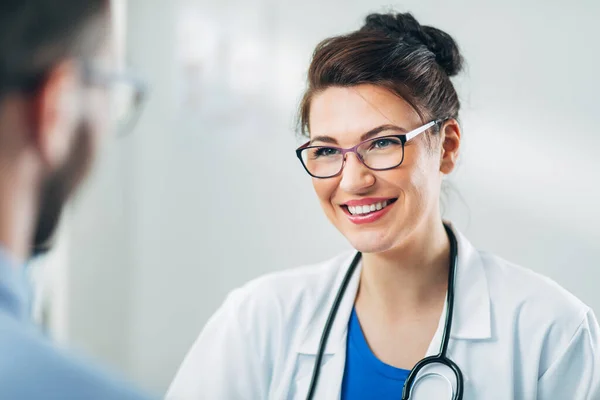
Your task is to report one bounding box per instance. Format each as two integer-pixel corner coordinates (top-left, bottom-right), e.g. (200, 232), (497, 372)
(342, 310), (410, 400)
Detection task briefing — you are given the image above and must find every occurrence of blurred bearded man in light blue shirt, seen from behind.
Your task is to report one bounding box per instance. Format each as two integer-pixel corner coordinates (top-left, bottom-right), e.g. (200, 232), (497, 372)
(0, 0), (155, 400)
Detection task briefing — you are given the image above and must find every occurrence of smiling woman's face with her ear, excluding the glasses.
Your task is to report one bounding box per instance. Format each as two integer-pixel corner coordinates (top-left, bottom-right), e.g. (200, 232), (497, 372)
(309, 85), (460, 253)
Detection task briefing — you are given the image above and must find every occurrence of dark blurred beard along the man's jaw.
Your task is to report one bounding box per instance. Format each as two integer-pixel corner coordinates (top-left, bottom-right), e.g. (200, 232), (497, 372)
(31, 123), (93, 256)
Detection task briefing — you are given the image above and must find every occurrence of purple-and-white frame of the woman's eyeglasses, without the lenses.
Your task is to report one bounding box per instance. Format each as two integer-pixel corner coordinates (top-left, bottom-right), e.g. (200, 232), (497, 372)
(296, 118), (449, 179)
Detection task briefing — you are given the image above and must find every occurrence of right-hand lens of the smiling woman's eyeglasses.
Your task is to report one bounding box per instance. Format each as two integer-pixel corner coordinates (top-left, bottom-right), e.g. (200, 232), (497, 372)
(357, 136), (404, 169)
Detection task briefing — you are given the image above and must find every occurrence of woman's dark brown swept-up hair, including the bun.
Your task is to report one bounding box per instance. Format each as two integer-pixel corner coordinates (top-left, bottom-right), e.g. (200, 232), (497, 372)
(299, 13), (463, 136)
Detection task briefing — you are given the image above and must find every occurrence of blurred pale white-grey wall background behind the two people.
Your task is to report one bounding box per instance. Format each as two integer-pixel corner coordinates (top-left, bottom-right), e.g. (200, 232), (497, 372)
(29, 0), (600, 393)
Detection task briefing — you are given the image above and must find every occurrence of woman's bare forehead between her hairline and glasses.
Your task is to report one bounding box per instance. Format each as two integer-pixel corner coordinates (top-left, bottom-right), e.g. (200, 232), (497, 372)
(309, 85), (421, 140)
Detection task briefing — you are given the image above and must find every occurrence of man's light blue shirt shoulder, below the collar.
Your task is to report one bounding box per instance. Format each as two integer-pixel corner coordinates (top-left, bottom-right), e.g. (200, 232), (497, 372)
(0, 313), (154, 400)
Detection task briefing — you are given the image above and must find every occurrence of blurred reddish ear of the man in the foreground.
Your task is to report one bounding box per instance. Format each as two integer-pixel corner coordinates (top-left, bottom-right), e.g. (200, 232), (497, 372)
(32, 60), (81, 169)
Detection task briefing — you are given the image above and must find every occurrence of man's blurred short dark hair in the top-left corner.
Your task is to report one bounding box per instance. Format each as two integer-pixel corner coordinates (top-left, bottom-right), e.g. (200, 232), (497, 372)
(0, 0), (109, 97)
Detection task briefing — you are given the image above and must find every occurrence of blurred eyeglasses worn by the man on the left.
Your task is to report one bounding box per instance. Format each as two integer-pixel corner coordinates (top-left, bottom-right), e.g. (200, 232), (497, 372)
(84, 63), (148, 136)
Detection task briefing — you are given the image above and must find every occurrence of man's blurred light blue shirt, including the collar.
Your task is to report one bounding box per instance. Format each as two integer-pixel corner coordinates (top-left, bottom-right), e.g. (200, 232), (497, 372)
(0, 248), (155, 400)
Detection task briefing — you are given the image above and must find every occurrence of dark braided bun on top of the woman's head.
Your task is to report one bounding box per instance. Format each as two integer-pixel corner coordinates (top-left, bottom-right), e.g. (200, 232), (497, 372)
(361, 13), (463, 76)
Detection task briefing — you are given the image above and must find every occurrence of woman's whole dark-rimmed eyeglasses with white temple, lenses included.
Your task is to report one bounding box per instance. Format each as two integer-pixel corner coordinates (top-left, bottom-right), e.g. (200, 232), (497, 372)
(296, 119), (446, 179)
